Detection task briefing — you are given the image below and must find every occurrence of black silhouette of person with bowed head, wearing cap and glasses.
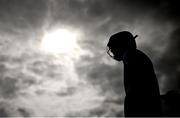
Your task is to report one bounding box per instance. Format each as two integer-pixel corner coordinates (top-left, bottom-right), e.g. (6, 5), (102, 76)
(107, 31), (162, 117)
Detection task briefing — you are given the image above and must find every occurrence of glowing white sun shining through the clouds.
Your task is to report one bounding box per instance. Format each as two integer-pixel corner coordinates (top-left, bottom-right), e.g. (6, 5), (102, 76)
(41, 29), (77, 54)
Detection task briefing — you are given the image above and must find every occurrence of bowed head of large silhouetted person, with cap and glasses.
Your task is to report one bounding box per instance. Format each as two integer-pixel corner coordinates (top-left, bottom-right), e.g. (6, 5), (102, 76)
(107, 31), (137, 61)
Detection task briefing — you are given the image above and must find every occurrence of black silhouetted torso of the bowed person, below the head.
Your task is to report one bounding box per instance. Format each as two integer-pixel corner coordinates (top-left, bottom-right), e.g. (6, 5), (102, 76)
(123, 50), (161, 116)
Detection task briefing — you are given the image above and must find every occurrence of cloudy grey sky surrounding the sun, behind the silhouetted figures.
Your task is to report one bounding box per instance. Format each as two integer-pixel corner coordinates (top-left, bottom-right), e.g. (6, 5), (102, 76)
(0, 0), (180, 117)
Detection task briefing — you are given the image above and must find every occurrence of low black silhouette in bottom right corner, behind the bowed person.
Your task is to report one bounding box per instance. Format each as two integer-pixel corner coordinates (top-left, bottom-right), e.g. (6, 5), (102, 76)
(161, 90), (180, 117)
